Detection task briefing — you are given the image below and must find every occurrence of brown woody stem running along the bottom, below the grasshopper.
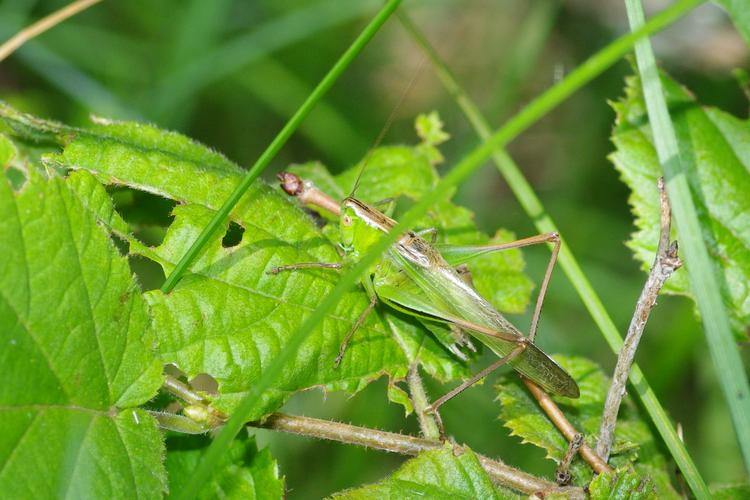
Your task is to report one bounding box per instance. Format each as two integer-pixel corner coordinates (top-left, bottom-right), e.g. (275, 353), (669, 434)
(248, 413), (584, 498)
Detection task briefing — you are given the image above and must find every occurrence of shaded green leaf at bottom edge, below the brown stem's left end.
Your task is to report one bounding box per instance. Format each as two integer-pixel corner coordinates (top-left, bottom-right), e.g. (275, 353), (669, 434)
(166, 436), (284, 500)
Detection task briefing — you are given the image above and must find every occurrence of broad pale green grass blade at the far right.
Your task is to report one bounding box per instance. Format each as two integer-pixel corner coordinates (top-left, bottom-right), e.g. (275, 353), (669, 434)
(625, 0), (750, 474)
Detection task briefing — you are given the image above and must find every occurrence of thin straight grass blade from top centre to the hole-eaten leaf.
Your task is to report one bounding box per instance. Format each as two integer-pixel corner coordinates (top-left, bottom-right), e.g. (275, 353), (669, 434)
(161, 0), (401, 293)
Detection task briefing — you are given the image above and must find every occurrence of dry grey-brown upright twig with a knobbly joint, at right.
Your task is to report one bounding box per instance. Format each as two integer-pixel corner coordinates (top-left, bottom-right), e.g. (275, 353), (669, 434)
(596, 178), (682, 460)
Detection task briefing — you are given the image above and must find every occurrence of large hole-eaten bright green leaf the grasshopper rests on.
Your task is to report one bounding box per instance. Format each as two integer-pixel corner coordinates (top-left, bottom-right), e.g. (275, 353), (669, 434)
(0, 107), (531, 418)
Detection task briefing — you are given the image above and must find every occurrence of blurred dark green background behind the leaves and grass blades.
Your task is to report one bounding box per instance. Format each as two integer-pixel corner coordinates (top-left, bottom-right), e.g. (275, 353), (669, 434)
(0, 0), (748, 498)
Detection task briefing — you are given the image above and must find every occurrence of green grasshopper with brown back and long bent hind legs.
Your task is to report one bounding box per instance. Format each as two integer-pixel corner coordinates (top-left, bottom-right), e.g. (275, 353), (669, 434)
(270, 173), (579, 411)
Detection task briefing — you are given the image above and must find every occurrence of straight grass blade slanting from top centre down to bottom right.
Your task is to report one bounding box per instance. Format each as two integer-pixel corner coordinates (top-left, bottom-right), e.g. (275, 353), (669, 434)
(397, 8), (708, 497)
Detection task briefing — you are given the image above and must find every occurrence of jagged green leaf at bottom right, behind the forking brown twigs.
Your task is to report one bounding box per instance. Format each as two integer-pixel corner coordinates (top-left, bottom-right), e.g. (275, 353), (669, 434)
(497, 356), (677, 498)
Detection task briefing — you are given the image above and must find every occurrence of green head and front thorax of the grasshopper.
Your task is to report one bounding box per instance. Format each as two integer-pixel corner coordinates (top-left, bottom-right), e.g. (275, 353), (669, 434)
(340, 198), (396, 256)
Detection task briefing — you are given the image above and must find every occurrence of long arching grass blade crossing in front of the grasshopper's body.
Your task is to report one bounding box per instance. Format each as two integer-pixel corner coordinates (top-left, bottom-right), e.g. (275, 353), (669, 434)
(183, 0), (700, 496)
